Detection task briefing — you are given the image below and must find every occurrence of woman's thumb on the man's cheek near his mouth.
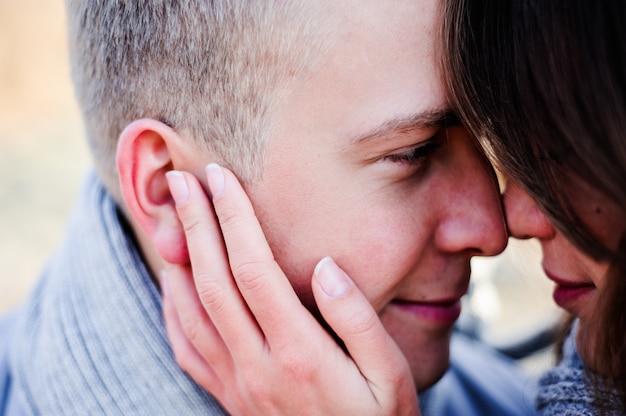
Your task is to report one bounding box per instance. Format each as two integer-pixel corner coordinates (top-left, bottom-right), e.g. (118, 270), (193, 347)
(312, 257), (415, 395)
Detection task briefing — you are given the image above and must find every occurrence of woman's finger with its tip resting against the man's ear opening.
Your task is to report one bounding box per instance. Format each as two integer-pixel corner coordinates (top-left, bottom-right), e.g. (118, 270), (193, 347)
(167, 172), (265, 357)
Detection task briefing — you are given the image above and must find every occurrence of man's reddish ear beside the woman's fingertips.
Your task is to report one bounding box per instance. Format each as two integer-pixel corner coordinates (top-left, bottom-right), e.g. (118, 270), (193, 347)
(117, 119), (189, 264)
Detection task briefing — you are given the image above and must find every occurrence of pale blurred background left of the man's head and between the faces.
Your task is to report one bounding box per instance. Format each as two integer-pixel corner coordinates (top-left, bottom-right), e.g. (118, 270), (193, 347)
(0, 0), (558, 372)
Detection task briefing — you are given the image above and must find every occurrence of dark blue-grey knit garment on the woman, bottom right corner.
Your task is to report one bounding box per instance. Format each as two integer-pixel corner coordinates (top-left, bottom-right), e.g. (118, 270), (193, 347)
(537, 324), (626, 416)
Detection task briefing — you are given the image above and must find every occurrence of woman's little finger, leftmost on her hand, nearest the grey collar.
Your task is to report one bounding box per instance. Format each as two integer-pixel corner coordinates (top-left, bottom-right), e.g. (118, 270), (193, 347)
(161, 268), (222, 392)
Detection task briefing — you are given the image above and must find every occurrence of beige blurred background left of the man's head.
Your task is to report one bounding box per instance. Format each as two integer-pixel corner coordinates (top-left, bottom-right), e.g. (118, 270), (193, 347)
(0, 0), (90, 312)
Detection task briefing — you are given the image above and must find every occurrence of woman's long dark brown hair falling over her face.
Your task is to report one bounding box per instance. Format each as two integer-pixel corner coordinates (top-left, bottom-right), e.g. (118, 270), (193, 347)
(443, 0), (626, 407)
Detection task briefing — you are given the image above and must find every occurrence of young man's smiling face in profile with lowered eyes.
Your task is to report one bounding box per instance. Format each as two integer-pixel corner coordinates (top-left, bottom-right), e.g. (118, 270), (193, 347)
(222, 0), (506, 388)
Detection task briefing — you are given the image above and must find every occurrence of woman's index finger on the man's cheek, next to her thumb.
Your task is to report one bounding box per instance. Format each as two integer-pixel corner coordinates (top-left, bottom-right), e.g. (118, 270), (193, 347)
(206, 164), (323, 346)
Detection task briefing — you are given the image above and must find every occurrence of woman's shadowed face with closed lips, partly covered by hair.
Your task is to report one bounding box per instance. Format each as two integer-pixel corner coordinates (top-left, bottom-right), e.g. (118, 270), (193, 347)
(503, 176), (624, 363)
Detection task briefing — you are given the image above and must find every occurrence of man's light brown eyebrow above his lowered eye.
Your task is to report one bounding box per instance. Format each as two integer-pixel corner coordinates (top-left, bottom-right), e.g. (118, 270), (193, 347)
(351, 109), (461, 143)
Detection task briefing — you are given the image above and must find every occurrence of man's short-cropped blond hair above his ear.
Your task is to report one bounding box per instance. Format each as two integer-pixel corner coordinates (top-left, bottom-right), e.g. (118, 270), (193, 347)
(66, 0), (328, 197)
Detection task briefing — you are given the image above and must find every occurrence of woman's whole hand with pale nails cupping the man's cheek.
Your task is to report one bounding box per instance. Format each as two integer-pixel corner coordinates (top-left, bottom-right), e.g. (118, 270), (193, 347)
(162, 164), (419, 415)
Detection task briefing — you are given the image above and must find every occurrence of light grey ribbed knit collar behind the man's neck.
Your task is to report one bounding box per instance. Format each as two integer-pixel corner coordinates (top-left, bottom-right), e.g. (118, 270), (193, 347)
(12, 174), (224, 416)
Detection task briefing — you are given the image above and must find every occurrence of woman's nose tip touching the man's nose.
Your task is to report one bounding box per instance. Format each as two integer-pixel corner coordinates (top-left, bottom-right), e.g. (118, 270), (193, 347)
(503, 180), (554, 239)
